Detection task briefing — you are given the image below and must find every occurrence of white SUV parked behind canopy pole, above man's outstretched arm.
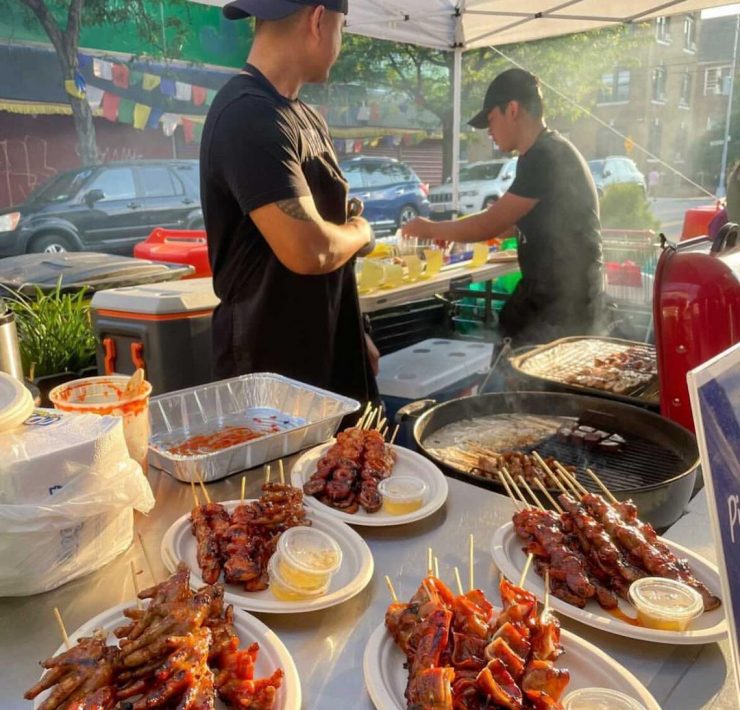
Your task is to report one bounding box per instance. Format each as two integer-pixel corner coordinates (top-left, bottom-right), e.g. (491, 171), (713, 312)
(429, 158), (517, 219)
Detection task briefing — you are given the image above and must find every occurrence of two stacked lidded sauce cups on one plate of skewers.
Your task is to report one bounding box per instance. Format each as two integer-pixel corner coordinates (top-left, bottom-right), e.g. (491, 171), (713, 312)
(275, 526), (342, 594)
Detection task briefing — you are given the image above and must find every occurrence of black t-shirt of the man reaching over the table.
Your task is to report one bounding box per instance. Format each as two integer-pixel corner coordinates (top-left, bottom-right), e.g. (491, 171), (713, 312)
(509, 129), (604, 313)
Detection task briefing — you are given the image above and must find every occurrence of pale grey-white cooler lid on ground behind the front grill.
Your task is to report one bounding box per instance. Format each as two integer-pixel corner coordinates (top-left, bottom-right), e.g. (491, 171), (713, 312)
(377, 338), (493, 399)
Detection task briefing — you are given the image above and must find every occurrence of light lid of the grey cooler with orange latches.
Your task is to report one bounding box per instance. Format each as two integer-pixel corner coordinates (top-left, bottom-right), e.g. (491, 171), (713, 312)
(92, 278), (219, 315)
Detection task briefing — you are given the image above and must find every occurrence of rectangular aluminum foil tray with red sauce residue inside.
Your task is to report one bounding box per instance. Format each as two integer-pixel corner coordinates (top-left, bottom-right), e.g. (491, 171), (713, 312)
(149, 373), (360, 482)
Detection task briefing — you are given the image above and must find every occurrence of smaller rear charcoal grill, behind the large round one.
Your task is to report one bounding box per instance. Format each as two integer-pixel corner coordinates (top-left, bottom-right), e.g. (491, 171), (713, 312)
(509, 336), (659, 408)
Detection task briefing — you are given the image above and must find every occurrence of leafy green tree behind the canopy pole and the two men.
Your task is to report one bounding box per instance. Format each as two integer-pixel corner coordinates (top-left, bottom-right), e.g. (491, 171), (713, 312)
(332, 26), (646, 181)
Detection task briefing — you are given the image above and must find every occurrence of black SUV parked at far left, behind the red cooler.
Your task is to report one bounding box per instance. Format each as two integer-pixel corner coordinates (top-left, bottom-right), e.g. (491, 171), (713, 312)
(0, 160), (203, 256)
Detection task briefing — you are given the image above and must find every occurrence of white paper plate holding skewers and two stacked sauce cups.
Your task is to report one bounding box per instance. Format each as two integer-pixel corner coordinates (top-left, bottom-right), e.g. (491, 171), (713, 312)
(161, 500), (374, 614)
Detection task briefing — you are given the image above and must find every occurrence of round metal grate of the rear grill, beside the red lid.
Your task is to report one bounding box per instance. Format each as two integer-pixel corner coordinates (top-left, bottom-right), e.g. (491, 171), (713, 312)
(512, 338), (657, 399)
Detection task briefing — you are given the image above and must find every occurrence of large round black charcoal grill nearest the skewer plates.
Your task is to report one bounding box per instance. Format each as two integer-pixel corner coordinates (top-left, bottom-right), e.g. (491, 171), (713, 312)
(401, 392), (699, 530)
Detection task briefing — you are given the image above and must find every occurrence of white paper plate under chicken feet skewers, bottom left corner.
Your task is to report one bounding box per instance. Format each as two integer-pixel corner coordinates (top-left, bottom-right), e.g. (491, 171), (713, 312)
(33, 600), (301, 710)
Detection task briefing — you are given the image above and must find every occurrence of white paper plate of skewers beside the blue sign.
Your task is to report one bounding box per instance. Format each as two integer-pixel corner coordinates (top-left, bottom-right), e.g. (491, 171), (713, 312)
(491, 523), (727, 645)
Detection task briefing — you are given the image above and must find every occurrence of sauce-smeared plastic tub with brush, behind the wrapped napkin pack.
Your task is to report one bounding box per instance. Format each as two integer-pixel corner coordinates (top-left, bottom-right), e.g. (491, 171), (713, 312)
(49, 375), (152, 473)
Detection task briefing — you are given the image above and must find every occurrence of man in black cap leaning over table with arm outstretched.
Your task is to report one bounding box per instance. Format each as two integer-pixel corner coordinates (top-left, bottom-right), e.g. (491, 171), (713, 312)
(403, 69), (604, 344)
